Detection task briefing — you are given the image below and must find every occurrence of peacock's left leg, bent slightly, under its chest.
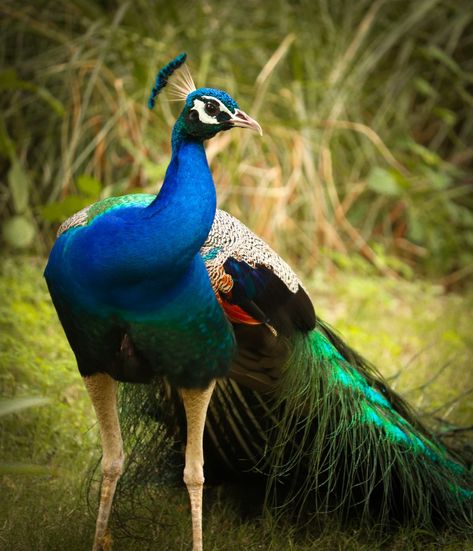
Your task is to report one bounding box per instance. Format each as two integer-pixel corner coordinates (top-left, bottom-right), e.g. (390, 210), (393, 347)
(84, 373), (123, 551)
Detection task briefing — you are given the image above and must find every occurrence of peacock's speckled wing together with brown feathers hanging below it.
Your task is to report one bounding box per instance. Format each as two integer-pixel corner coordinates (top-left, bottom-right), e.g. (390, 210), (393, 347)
(201, 210), (316, 392)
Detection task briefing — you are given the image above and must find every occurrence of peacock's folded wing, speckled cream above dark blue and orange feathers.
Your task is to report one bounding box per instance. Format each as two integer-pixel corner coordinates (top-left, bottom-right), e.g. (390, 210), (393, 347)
(201, 210), (315, 336)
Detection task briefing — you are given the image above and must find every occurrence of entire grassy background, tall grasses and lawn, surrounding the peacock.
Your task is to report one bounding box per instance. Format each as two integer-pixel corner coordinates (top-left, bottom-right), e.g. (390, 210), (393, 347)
(0, 0), (473, 551)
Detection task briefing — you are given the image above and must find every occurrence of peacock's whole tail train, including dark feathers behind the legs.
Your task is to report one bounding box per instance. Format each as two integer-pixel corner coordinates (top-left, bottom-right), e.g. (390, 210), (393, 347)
(112, 321), (473, 533)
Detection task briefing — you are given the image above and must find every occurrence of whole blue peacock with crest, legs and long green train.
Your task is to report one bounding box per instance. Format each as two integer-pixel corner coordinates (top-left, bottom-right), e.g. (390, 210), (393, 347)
(45, 54), (473, 551)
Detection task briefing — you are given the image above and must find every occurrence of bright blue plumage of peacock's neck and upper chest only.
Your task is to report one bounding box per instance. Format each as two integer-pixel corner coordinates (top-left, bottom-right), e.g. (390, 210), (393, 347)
(48, 124), (216, 319)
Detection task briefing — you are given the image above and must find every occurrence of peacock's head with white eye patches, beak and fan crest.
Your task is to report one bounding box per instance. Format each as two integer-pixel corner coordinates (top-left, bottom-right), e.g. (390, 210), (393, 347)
(148, 54), (263, 140)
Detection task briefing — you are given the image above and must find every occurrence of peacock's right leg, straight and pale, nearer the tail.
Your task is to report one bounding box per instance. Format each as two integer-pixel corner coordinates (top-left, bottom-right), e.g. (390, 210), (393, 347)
(181, 381), (215, 551)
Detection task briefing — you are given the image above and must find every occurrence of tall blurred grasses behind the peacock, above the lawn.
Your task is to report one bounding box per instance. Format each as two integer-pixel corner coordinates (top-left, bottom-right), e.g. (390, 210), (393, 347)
(0, 0), (473, 282)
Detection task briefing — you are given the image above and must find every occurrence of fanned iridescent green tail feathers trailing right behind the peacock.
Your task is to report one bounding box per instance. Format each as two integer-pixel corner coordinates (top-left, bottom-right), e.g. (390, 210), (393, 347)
(260, 323), (473, 531)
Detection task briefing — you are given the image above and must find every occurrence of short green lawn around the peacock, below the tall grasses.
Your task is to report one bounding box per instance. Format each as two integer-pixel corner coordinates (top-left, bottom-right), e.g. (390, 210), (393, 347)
(0, 257), (473, 551)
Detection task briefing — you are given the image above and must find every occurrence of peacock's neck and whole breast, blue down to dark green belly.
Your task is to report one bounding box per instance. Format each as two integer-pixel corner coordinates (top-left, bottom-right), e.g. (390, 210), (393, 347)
(45, 137), (235, 387)
